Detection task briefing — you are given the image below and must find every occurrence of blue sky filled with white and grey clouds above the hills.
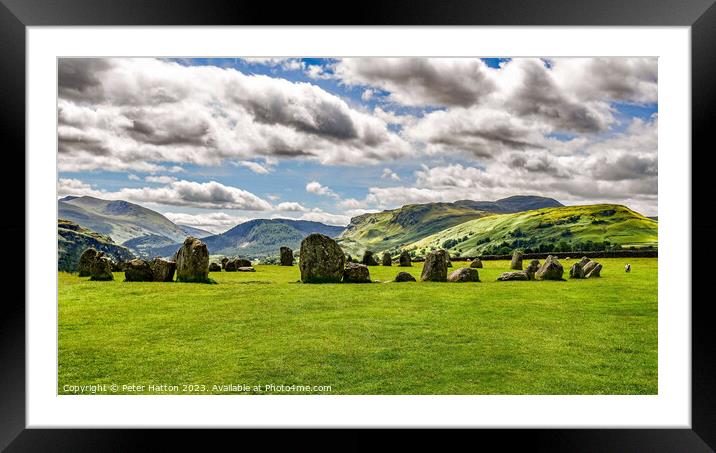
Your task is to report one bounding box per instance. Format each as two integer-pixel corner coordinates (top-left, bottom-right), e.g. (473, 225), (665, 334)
(58, 58), (658, 233)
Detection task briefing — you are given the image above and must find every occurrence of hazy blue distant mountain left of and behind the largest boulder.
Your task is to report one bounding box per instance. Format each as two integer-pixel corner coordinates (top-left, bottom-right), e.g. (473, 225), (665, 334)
(148, 219), (344, 258)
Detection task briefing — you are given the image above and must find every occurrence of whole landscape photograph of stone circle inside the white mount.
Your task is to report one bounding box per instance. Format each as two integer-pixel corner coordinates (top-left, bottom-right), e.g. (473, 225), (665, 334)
(56, 57), (659, 395)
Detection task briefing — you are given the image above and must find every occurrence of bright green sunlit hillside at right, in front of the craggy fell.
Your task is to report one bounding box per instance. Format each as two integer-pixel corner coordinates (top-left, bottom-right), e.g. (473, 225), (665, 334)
(403, 204), (658, 256)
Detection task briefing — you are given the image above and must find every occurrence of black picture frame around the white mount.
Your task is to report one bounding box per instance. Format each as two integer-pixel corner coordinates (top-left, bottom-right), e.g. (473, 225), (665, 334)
(0, 0), (716, 452)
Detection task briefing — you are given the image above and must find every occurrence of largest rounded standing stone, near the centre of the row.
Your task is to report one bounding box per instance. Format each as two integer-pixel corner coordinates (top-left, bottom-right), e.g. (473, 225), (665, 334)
(298, 233), (345, 283)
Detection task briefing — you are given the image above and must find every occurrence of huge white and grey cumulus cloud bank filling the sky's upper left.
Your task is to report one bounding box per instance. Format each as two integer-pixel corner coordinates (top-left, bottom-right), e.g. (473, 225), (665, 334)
(58, 59), (410, 172)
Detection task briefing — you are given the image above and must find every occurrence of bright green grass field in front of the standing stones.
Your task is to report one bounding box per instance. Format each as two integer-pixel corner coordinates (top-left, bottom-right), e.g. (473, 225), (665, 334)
(58, 258), (657, 394)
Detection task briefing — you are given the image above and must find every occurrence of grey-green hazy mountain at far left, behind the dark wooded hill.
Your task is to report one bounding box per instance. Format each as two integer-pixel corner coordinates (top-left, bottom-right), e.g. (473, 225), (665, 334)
(57, 196), (187, 244)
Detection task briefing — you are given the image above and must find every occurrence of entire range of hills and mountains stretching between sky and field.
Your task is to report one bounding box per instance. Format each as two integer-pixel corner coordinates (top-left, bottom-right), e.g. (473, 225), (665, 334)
(58, 195), (658, 259)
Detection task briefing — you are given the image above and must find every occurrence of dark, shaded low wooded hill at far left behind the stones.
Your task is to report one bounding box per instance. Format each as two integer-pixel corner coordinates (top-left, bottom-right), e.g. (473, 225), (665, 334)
(57, 219), (134, 272)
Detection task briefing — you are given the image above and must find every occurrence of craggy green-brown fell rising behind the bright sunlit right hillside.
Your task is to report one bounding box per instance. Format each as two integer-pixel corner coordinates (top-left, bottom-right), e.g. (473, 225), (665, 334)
(338, 195), (562, 256)
